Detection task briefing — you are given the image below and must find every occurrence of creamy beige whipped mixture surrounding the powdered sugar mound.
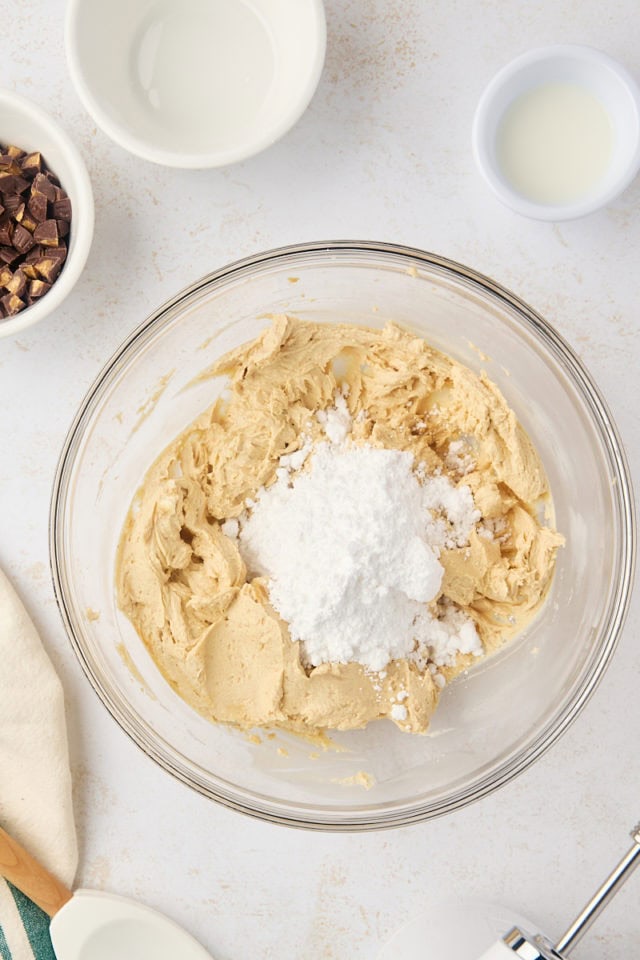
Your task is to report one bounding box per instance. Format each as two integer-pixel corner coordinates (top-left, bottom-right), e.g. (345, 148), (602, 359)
(117, 316), (562, 733)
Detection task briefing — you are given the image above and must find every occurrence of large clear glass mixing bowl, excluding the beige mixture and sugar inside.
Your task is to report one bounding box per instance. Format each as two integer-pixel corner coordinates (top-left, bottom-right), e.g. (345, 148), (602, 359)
(51, 242), (635, 830)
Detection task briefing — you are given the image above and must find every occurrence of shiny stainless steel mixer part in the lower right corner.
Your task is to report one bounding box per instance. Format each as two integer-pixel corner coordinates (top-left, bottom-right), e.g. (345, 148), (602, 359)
(480, 824), (640, 960)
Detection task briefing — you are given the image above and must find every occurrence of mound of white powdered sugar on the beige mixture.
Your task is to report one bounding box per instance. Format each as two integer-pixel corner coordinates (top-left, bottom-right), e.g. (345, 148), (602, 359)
(235, 424), (481, 671)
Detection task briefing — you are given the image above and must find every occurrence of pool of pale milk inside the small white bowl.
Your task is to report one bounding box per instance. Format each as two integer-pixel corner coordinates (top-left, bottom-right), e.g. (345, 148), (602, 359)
(496, 83), (613, 204)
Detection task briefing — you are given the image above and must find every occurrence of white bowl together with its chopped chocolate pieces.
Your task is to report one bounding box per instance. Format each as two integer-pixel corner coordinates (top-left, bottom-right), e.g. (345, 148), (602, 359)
(0, 90), (93, 337)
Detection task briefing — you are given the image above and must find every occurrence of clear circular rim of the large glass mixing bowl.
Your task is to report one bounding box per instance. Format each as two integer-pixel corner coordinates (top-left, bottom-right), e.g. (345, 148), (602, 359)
(49, 240), (636, 832)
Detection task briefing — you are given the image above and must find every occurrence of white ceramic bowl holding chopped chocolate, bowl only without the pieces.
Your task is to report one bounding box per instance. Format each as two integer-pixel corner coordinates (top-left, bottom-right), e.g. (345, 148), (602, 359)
(0, 90), (93, 337)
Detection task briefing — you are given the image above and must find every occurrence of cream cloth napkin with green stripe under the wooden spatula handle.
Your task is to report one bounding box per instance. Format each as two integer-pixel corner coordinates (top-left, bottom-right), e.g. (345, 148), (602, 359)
(0, 570), (78, 960)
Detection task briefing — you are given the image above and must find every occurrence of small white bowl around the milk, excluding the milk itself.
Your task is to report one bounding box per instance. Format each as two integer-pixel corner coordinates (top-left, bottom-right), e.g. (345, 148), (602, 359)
(472, 44), (640, 221)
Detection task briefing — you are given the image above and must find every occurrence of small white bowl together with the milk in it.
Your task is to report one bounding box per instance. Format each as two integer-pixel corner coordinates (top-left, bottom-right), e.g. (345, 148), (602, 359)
(473, 45), (640, 221)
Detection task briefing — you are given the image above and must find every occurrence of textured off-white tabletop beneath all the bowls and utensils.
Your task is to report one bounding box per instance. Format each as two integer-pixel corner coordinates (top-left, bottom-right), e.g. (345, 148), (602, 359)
(0, 0), (640, 960)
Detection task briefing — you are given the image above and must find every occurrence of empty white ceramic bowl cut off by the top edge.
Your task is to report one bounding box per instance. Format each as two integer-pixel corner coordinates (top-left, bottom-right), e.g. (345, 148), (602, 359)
(66, 0), (326, 168)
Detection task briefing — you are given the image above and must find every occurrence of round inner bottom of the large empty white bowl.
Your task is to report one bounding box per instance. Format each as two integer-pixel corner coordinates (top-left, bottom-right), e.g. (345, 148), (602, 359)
(131, 0), (275, 150)
